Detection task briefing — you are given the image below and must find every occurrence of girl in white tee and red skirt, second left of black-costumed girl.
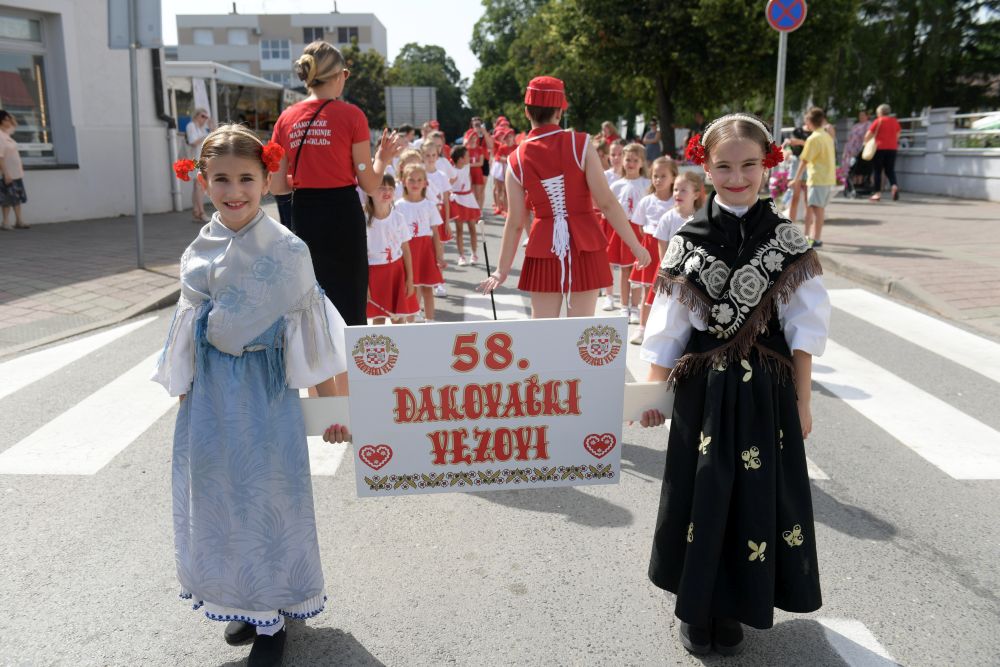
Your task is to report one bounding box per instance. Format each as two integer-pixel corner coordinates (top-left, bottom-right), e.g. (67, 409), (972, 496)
(629, 157), (677, 345)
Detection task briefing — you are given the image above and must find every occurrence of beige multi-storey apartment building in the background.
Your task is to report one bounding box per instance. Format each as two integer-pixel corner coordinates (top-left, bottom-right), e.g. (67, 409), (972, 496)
(177, 12), (388, 87)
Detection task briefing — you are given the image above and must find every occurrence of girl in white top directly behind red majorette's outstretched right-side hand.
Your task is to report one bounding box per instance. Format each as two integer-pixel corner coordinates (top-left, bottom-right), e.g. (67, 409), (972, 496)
(608, 144), (649, 324)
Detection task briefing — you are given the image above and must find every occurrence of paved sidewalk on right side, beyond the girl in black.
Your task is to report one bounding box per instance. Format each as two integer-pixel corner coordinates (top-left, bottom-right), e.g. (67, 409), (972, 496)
(812, 193), (1000, 337)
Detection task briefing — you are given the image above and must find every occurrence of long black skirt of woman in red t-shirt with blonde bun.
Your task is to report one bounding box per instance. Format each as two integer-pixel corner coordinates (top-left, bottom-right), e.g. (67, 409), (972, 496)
(292, 186), (368, 325)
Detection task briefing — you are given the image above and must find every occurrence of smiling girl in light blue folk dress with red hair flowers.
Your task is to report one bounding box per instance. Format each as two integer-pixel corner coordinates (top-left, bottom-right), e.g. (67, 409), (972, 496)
(153, 125), (347, 665)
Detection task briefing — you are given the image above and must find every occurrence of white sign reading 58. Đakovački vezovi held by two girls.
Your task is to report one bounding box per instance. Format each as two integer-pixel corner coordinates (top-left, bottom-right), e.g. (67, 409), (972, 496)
(346, 318), (627, 496)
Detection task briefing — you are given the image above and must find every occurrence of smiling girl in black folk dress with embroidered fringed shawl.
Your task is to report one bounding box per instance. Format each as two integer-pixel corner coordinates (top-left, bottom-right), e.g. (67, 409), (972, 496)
(642, 114), (830, 655)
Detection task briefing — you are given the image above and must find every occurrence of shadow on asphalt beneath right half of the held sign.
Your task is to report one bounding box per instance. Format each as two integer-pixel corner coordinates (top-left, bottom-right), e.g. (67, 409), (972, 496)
(470, 486), (633, 528)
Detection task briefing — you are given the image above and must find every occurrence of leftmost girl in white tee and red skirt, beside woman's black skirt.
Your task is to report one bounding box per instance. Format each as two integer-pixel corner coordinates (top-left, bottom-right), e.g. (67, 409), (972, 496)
(365, 175), (420, 324)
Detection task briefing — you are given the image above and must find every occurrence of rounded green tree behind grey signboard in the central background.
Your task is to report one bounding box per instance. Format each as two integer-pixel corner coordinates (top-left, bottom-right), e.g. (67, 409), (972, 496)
(388, 42), (472, 140)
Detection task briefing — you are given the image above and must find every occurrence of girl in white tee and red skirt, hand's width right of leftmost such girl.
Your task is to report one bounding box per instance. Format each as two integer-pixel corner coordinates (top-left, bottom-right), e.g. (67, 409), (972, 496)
(396, 164), (447, 322)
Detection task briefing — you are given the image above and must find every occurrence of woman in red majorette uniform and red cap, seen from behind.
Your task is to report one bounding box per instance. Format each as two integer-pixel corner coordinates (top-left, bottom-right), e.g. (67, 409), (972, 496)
(479, 76), (649, 318)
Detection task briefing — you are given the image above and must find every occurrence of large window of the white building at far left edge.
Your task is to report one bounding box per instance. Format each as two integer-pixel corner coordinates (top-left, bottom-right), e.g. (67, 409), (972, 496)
(0, 15), (55, 165)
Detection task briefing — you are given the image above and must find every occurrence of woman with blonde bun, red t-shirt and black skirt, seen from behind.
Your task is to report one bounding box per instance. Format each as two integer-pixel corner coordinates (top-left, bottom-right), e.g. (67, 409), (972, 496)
(271, 42), (403, 340)
